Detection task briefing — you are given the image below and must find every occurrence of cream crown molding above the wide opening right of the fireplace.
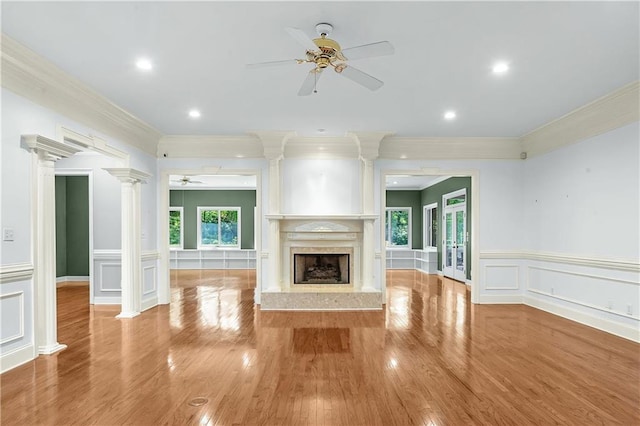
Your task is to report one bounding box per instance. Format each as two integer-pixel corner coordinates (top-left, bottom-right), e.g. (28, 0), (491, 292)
(378, 136), (522, 160)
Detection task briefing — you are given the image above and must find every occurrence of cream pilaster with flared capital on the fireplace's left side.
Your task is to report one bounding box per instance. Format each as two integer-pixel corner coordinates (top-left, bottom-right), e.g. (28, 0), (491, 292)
(255, 131), (295, 291)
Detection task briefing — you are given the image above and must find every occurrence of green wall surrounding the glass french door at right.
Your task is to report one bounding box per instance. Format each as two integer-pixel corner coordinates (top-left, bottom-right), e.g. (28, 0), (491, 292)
(421, 177), (471, 279)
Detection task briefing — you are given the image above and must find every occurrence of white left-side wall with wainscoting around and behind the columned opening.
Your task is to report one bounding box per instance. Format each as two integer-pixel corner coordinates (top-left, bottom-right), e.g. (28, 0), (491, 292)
(0, 89), (157, 371)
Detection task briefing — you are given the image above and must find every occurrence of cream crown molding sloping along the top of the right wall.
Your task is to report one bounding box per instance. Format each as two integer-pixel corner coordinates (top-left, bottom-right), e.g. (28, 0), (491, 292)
(520, 81), (640, 157)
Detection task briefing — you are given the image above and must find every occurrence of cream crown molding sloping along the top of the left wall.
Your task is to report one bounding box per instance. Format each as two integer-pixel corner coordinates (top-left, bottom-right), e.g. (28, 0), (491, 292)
(0, 34), (162, 155)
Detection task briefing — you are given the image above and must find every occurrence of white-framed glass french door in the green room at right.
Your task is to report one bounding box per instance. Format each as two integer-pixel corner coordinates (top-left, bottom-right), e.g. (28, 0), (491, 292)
(442, 191), (467, 282)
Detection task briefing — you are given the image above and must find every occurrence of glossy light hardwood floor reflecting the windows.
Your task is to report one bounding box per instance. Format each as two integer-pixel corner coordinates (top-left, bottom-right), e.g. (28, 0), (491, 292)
(0, 271), (640, 426)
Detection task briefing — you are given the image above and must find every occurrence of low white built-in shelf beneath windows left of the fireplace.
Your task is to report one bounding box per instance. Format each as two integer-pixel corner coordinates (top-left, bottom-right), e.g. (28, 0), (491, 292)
(169, 249), (256, 269)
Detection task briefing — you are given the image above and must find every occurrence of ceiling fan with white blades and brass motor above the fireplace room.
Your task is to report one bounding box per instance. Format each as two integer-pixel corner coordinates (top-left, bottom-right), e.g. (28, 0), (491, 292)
(247, 23), (394, 96)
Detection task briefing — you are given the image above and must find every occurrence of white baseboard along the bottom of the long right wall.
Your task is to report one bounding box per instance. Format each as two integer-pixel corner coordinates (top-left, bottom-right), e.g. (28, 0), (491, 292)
(524, 296), (640, 343)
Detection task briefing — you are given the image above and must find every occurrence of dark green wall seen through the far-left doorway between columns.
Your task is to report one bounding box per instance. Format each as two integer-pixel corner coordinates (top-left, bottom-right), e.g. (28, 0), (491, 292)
(56, 176), (89, 277)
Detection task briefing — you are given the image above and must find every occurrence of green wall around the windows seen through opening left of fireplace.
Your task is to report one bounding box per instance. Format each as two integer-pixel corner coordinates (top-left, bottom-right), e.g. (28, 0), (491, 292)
(174, 189), (256, 249)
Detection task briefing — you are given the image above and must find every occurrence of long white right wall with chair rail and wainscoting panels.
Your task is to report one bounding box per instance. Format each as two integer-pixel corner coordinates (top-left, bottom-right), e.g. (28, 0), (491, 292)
(523, 123), (640, 341)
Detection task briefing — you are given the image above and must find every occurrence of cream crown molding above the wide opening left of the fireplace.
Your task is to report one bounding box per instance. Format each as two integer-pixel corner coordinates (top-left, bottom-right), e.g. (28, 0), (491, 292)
(157, 135), (264, 158)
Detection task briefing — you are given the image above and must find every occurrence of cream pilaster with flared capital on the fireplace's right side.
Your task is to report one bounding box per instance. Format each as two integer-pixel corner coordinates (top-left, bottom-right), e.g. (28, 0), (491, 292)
(351, 132), (389, 291)
